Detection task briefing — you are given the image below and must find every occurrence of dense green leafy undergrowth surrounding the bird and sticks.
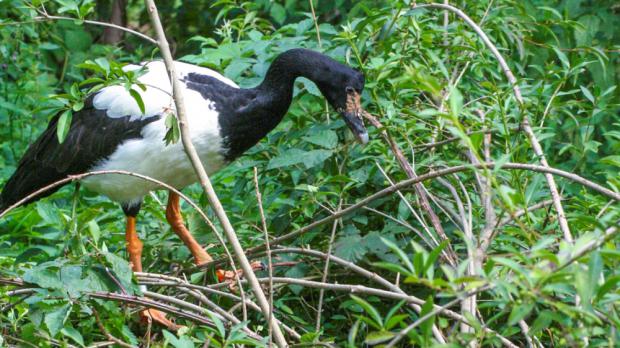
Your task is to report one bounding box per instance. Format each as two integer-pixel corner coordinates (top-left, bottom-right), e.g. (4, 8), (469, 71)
(0, 0), (620, 347)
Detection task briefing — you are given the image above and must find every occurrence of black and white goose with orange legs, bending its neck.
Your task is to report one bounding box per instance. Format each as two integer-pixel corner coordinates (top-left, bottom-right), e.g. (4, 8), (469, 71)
(0, 48), (368, 329)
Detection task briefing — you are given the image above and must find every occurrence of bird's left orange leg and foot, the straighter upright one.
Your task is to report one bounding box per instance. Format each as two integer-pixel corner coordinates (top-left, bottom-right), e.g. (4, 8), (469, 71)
(125, 216), (181, 331)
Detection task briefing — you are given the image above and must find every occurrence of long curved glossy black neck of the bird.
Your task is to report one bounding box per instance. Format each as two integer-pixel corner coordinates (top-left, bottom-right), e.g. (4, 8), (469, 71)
(195, 49), (338, 160)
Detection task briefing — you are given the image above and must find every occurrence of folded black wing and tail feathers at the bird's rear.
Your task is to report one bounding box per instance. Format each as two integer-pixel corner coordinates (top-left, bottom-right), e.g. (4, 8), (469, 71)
(0, 97), (159, 212)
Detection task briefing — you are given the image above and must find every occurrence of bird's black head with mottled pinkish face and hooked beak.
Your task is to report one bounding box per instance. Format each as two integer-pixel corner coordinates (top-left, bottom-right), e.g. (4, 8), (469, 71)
(317, 63), (368, 144)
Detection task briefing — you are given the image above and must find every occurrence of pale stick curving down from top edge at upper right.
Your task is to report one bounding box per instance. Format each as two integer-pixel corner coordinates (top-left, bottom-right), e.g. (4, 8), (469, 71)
(412, 3), (573, 243)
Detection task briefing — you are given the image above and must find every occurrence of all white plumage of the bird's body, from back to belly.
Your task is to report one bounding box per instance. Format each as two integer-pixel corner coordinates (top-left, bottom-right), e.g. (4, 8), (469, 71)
(83, 62), (237, 203)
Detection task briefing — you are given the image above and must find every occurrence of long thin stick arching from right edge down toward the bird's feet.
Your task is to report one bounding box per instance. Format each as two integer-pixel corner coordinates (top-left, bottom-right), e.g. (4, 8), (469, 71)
(229, 162), (620, 260)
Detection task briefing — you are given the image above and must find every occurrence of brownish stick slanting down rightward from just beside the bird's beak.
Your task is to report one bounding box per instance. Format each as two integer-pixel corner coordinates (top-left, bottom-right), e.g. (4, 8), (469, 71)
(362, 111), (458, 264)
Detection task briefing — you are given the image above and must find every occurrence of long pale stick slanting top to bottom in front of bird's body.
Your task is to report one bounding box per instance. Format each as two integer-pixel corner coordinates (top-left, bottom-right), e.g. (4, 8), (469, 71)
(144, 0), (287, 347)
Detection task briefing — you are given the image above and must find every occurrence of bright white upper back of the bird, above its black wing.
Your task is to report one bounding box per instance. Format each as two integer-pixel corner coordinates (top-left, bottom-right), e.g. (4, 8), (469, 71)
(93, 61), (238, 121)
